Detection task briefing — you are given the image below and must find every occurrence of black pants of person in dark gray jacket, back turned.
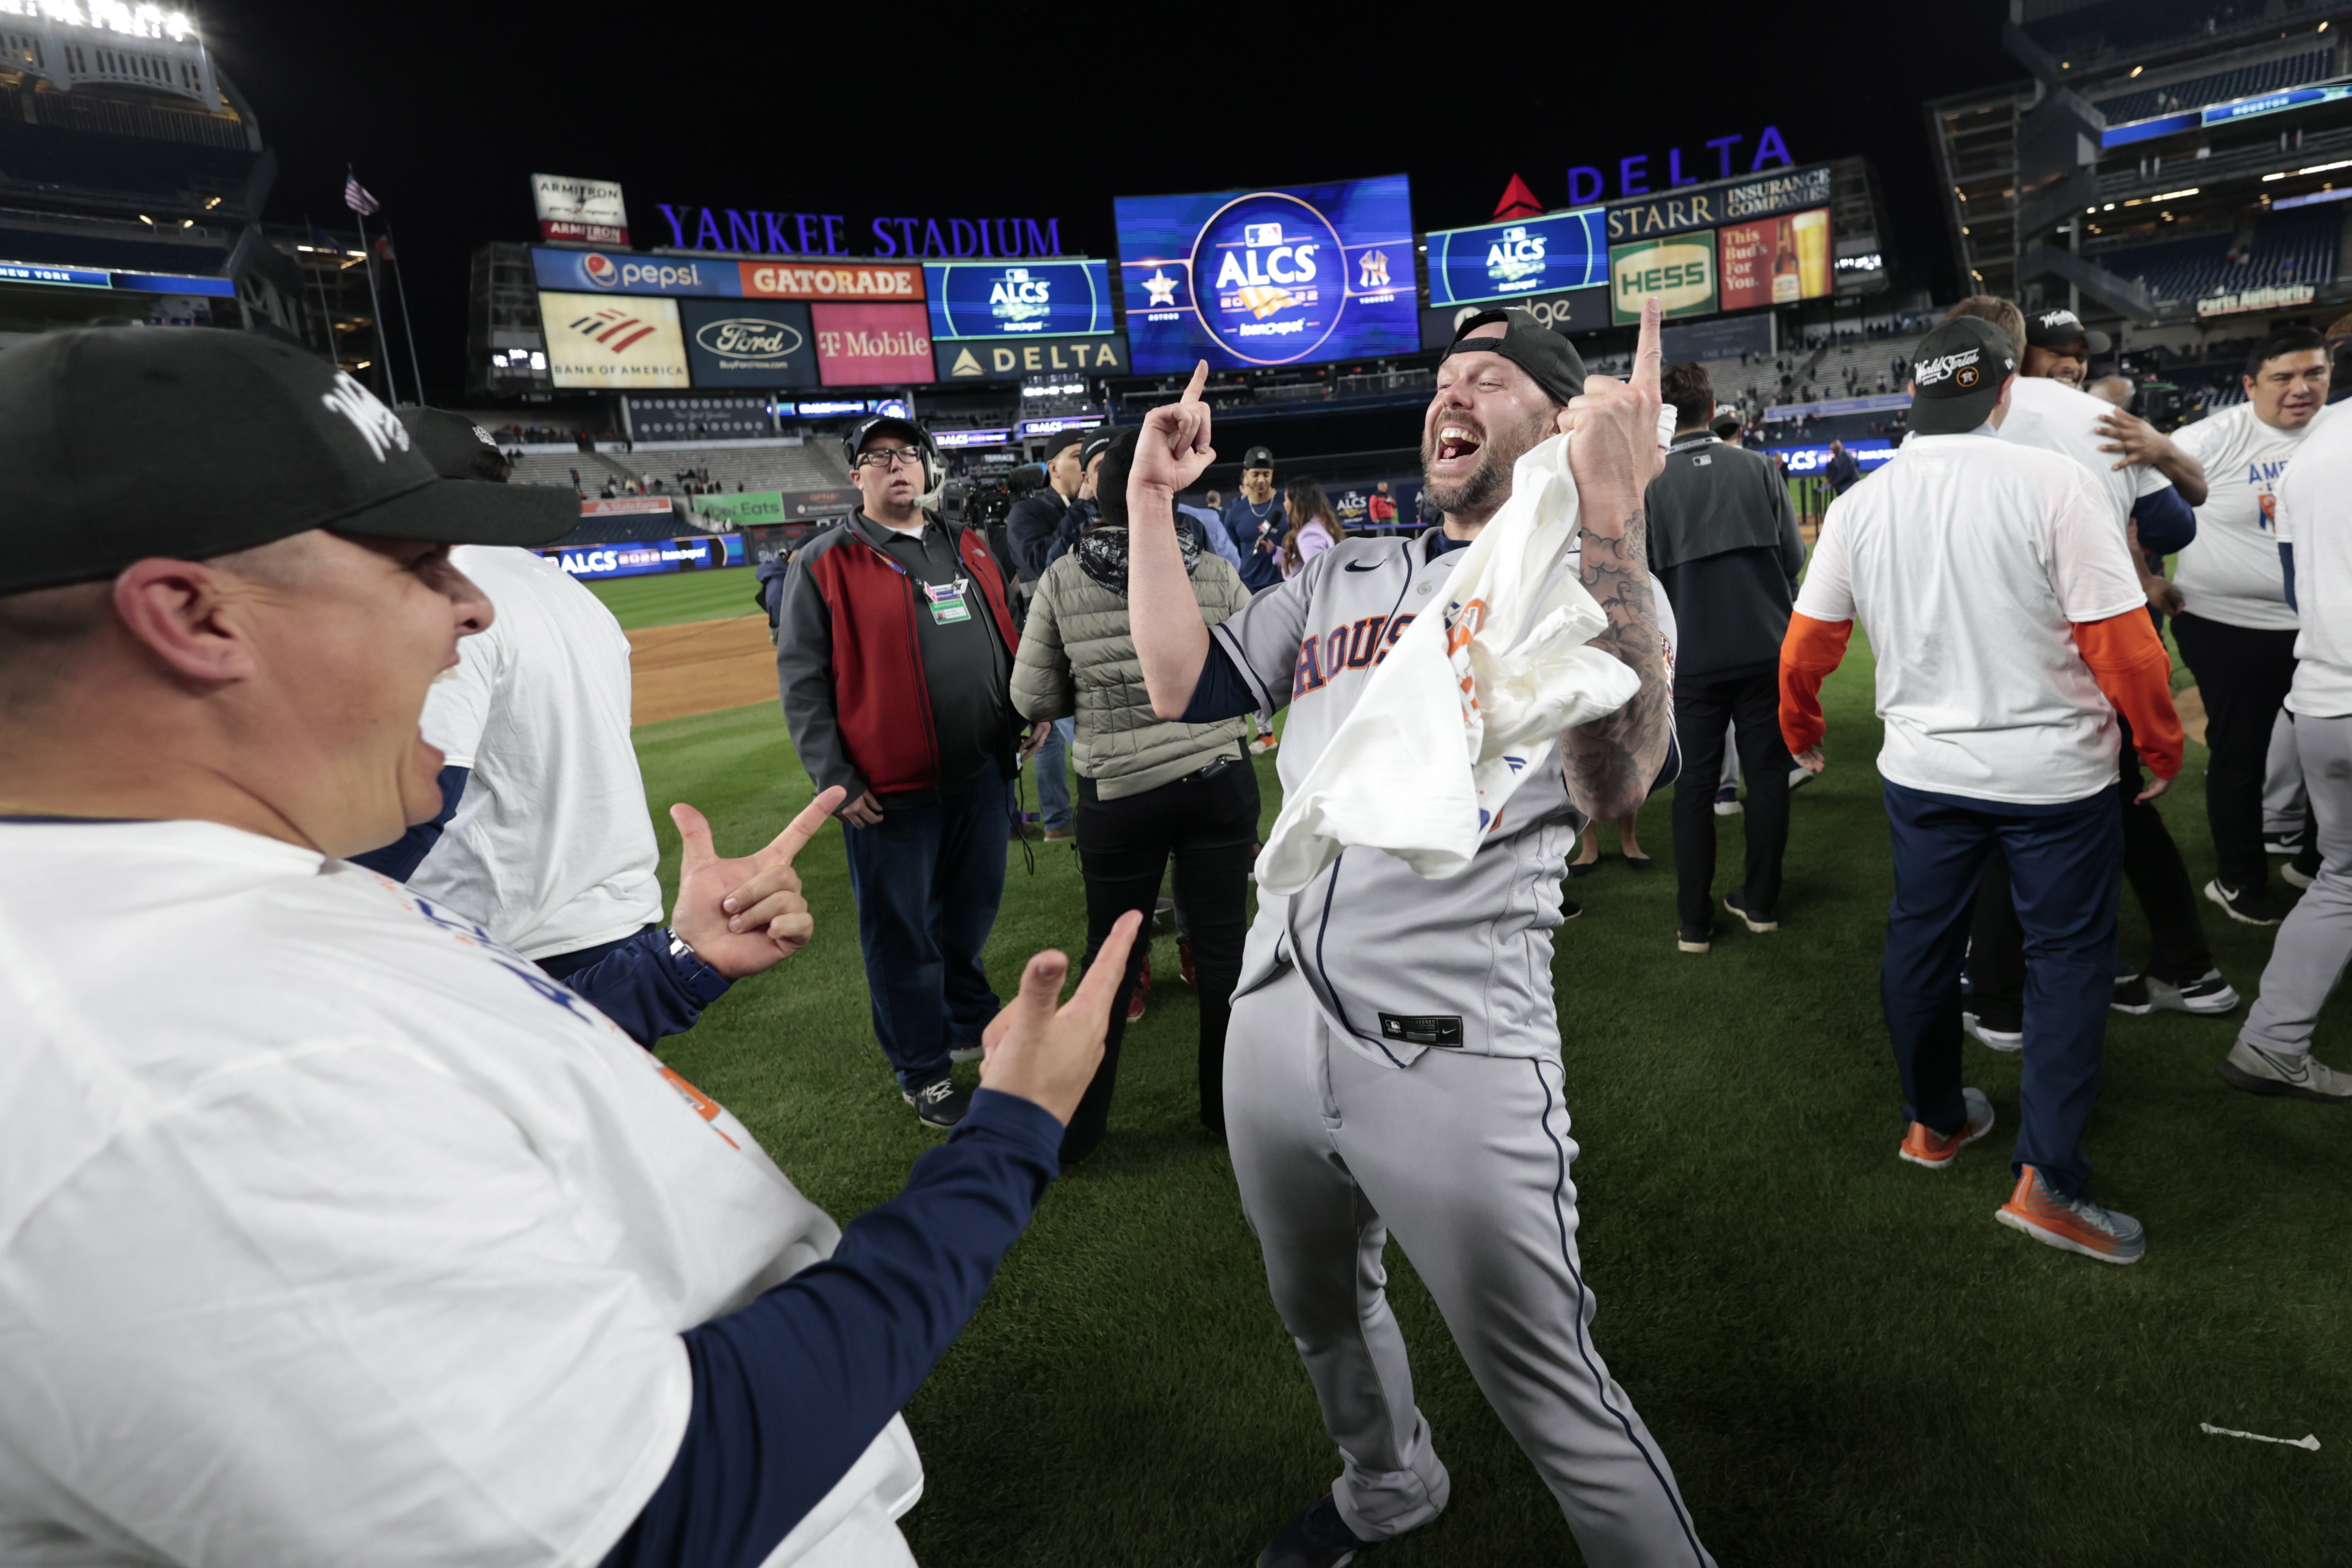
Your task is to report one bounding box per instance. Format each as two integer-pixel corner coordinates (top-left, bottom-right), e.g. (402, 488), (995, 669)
(1674, 665), (1797, 926)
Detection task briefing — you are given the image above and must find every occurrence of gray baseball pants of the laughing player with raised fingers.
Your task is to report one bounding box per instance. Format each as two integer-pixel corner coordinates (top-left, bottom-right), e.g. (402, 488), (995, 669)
(1225, 971), (1715, 1568)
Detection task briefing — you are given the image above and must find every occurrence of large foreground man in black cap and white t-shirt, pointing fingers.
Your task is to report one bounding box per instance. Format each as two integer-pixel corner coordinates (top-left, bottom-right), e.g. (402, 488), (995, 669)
(0, 327), (1134, 1568)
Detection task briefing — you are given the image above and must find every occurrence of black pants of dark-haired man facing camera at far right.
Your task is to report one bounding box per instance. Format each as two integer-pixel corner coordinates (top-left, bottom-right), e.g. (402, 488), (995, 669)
(2173, 613), (2296, 893)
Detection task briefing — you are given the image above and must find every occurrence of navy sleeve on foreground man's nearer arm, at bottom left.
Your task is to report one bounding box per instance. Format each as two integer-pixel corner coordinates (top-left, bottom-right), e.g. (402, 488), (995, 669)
(604, 1089), (1061, 1568)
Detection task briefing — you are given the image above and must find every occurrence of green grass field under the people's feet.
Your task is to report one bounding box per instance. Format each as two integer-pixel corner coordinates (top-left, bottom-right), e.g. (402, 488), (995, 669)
(611, 574), (2352, 1568)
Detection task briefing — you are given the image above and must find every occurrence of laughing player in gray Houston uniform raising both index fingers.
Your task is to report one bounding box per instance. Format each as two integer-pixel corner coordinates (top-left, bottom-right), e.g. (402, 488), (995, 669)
(1127, 303), (1712, 1568)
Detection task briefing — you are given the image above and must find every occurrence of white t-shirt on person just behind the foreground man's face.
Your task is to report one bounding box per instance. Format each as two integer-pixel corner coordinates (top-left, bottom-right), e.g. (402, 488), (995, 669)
(409, 545), (661, 959)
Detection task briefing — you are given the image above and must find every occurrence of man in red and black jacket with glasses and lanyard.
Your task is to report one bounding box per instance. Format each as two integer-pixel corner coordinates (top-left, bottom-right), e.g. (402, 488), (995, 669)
(776, 414), (1051, 1128)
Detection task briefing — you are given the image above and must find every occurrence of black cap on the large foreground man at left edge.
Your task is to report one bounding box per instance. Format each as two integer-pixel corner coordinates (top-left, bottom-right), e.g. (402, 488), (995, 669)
(0, 327), (579, 595)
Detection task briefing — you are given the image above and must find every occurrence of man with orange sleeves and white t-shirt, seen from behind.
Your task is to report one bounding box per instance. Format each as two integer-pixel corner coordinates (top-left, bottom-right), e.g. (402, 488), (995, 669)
(1780, 315), (2183, 1262)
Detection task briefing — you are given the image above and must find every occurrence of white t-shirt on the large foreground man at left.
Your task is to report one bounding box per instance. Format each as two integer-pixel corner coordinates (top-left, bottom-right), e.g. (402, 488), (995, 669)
(0, 823), (922, 1568)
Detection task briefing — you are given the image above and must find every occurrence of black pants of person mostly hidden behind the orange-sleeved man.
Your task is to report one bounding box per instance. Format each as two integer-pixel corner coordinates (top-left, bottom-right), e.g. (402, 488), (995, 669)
(1969, 717), (2213, 1010)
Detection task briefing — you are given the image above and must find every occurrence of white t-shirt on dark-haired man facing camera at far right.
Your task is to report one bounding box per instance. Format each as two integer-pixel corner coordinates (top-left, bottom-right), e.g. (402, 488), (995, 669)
(2173, 402), (2310, 632)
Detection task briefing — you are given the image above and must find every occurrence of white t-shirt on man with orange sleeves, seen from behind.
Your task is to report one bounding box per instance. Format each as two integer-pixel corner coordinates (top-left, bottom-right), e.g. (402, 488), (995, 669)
(1797, 432), (2147, 804)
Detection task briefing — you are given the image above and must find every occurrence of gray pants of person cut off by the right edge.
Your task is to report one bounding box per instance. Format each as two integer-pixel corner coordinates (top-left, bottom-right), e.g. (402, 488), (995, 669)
(2239, 715), (2352, 1056)
